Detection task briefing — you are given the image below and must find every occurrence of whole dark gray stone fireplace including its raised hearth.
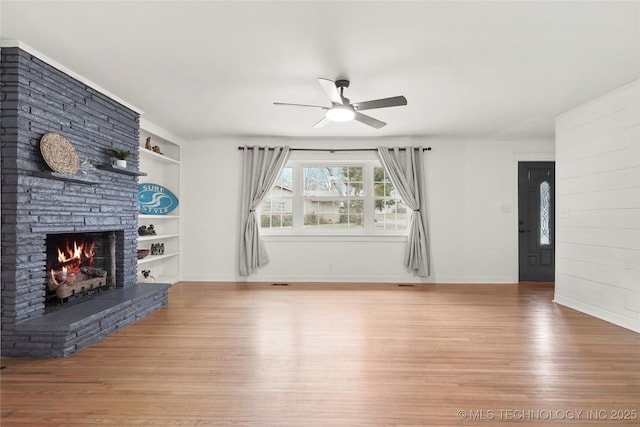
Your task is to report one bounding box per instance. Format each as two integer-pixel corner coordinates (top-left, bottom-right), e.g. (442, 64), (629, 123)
(0, 46), (168, 357)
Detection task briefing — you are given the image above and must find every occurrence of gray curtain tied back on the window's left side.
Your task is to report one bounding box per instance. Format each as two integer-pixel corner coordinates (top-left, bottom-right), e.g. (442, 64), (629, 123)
(238, 146), (289, 276)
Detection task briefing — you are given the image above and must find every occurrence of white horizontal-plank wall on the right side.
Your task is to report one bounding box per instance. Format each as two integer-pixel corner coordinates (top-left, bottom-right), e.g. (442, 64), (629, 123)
(555, 80), (640, 332)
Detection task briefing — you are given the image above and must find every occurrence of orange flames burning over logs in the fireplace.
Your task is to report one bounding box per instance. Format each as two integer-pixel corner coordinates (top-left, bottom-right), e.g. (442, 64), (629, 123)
(49, 241), (95, 289)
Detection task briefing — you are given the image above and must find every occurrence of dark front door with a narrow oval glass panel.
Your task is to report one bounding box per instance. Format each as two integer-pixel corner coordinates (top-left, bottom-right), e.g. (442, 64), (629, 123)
(518, 162), (555, 282)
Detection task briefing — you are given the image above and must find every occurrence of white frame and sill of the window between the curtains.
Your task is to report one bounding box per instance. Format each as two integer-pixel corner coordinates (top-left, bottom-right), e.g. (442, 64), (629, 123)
(257, 152), (409, 241)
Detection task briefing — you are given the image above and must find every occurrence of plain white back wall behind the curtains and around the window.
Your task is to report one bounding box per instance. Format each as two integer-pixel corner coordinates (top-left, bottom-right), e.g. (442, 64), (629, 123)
(180, 139), (554, 283)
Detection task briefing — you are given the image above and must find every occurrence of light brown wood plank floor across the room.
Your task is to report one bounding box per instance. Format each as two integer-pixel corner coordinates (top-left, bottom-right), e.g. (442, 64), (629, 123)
(0, 282), (640, 426)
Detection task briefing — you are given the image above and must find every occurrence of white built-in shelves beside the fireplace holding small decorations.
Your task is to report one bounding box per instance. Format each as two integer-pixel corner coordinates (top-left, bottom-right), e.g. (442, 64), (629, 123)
(138, 120), (180, 283)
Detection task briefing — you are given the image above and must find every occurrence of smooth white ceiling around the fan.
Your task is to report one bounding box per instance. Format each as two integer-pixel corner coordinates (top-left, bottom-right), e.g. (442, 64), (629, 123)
(0, 0), (640, 140)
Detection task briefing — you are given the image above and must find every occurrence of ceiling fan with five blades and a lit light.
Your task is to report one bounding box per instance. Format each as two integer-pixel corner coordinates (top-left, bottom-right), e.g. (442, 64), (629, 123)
(274, 78), (407, 129)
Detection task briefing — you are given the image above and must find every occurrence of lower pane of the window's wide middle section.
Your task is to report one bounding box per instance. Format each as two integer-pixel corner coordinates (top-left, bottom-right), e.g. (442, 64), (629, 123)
(303, 199), (364, 229)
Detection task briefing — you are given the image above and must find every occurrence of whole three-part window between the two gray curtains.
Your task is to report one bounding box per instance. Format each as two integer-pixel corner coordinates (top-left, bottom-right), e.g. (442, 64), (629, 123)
(260, 160), (408, 234)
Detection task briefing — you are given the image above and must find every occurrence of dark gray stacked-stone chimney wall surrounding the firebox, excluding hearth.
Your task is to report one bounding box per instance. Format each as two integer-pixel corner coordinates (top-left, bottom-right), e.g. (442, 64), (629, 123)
(0, 48), (165, 356)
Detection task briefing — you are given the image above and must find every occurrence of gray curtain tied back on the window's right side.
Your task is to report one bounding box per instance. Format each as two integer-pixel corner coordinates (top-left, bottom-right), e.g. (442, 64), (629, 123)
(378, 147), (430, 277)
